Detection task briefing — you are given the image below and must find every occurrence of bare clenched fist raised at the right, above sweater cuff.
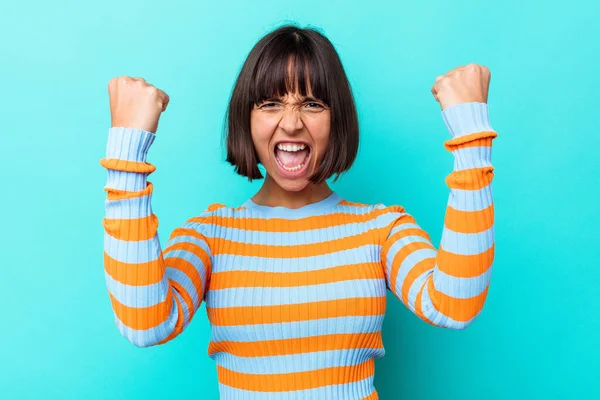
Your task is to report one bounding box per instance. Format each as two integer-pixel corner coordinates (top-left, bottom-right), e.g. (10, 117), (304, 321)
(431, 63), (491, 111)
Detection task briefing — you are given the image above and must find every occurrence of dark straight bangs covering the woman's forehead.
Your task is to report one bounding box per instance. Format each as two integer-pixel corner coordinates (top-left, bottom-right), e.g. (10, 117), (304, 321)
(250, 35), (330, 105)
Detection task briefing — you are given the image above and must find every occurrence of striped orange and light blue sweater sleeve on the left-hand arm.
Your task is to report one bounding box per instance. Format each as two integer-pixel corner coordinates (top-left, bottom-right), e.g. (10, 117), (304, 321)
(100, 127), (211, 347)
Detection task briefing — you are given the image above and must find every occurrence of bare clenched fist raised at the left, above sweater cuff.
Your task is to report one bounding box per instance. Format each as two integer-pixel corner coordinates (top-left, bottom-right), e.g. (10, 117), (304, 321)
(108, 76), (169, 133)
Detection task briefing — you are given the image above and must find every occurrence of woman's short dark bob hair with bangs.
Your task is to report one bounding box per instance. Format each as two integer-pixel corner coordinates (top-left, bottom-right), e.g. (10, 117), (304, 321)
(225, 24), (359, 183)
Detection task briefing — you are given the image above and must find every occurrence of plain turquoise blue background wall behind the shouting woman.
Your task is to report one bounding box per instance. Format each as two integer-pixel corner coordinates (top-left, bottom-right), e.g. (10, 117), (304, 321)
(0, 0), (600, 399)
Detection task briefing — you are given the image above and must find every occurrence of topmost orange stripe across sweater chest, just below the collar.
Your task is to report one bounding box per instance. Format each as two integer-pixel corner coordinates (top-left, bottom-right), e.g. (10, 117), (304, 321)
(188, 206), (404, 232)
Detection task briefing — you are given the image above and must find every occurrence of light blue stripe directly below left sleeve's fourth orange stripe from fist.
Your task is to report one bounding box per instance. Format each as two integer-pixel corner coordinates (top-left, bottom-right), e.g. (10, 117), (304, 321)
(104, 270), (169, 308)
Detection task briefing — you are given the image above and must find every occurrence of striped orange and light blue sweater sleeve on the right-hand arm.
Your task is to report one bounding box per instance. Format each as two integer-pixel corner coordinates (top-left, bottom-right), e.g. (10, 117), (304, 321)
(381, 102), (497, 329)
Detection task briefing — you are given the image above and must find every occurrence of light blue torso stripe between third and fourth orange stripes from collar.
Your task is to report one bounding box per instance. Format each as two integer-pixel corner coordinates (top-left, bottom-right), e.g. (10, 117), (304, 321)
(206, 279), (386, 308)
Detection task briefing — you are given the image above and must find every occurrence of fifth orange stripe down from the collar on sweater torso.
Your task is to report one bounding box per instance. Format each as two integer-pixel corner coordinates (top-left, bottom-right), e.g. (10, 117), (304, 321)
(208, 332), (383, 357)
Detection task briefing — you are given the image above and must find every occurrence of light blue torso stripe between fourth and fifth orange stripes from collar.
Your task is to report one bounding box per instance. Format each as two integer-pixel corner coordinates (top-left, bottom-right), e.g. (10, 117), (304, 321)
(211, 314), (385, 342)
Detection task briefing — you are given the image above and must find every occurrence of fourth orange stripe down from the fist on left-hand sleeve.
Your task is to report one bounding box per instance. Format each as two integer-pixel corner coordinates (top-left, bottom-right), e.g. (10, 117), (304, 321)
(104, 251), (165, 286)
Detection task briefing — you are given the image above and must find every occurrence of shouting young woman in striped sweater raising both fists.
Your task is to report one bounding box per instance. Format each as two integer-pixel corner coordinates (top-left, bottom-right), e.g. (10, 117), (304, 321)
(101, 25), (496, 399)
